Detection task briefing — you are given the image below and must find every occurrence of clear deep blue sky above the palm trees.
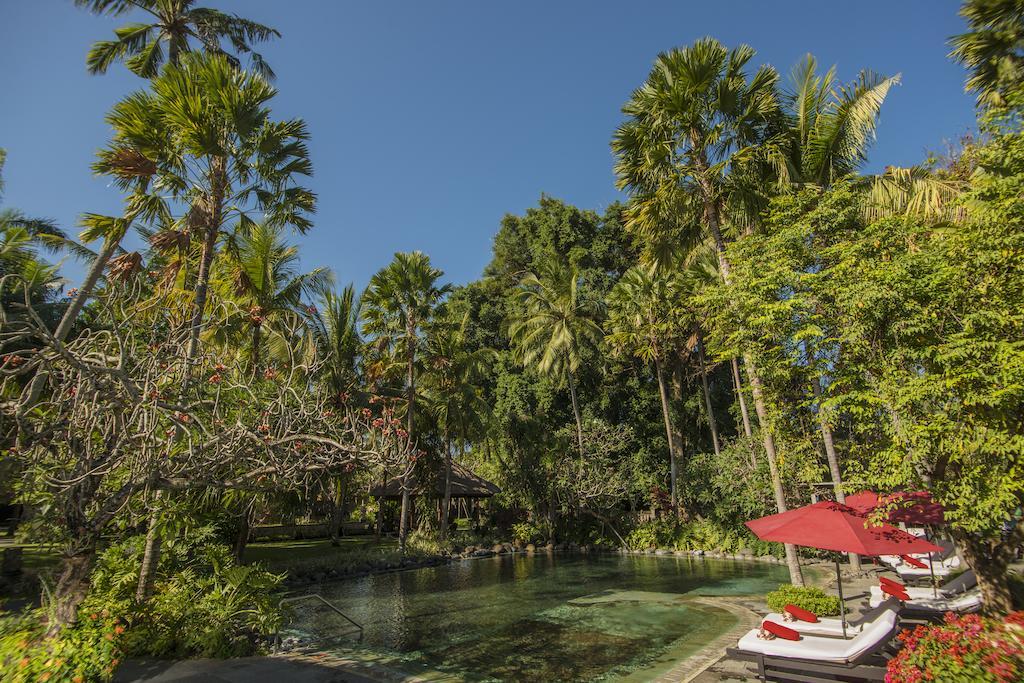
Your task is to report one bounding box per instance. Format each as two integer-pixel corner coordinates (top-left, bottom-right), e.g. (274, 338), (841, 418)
(0, 0), (974, 288)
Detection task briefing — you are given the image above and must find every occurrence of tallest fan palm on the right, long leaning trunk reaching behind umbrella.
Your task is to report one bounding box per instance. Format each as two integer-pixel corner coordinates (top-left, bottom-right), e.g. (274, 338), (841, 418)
(611, 38), (803, 584)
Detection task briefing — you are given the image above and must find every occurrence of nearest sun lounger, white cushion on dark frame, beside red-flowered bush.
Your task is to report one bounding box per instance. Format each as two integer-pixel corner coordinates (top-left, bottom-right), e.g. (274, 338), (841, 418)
(726, 610), (899, 683)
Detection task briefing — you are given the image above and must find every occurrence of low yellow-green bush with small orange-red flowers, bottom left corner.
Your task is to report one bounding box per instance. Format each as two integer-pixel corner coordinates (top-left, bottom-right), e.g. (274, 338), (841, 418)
(0, 609), (125, 683)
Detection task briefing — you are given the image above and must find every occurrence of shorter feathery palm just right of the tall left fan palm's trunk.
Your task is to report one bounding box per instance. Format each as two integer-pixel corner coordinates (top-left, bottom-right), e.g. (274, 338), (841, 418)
(214, 223), (333, 377)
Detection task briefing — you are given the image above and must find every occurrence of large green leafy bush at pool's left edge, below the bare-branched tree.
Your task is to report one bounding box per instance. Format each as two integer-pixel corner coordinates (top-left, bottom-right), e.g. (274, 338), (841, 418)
(82, 529), (283, 657)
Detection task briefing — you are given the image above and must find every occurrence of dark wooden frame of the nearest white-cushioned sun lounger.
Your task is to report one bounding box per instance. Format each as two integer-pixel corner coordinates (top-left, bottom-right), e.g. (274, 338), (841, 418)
(725, 622), (900, 683)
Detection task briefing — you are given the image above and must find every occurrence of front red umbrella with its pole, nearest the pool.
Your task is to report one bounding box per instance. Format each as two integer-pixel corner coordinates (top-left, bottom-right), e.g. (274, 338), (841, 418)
(746, 501), (942, 637)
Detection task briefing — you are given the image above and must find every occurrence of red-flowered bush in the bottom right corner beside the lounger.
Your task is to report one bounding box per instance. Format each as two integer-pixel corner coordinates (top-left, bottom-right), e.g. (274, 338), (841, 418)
(886, 611), (1024, 683)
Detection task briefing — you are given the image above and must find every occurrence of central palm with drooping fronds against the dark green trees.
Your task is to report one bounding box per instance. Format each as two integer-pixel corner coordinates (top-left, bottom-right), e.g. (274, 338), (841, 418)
(509, 259), (603, 457)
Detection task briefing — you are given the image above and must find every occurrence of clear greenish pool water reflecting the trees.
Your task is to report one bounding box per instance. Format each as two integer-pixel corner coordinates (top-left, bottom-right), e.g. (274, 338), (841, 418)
(284, 553), (787, 681)
